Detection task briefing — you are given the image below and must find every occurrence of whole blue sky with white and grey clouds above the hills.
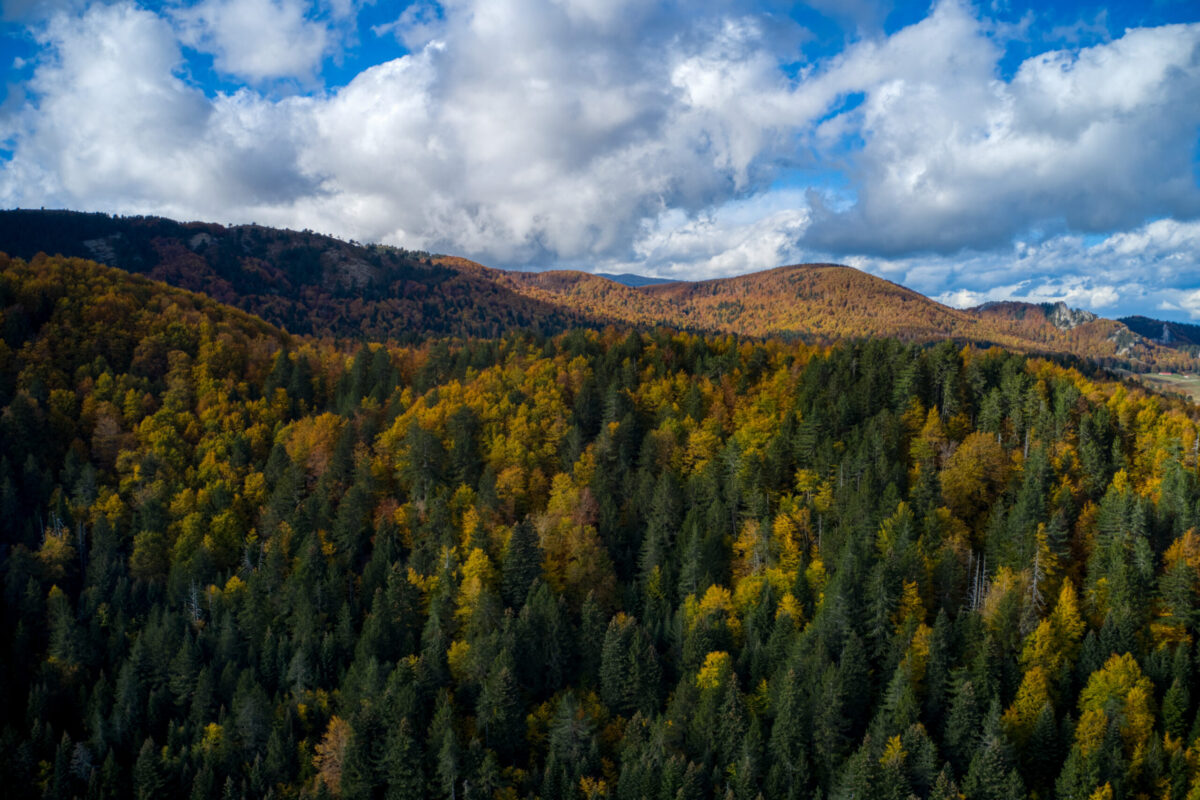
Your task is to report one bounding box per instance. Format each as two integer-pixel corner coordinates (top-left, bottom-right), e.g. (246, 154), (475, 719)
(0, 0), (1200, 320)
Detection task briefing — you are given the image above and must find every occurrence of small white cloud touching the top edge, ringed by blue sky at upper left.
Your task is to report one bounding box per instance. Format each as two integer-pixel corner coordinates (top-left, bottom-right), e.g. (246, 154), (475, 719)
(174, 0), (328, 83)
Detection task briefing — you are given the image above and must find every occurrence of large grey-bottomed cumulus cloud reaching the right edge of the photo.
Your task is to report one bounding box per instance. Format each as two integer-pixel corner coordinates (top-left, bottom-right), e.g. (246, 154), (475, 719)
(802, 2), (1200, 255)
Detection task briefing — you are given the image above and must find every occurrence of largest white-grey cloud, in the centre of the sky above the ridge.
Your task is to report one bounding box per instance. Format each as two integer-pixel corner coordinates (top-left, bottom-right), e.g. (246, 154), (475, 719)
(286, 0), (811, 264)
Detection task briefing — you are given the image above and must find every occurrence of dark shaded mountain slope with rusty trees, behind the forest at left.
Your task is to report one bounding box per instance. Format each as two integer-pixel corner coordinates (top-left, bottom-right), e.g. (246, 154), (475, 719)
(0, 211), (583, 341)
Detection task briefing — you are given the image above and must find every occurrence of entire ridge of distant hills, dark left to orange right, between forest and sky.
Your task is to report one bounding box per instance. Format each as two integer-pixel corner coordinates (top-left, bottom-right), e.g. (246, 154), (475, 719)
(0, 210), (1200, 372)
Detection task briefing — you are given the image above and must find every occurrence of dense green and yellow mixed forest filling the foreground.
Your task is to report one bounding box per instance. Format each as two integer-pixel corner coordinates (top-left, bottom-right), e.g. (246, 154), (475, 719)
(0, 251), (1200, 800)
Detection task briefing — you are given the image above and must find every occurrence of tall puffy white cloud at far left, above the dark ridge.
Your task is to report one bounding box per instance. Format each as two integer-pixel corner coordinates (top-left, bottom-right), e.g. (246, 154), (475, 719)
(0, 4), (313, 219)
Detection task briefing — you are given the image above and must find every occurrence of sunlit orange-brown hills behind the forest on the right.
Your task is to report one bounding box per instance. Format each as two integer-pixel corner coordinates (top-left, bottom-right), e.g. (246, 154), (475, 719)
(494, 264), (1200, 371)
